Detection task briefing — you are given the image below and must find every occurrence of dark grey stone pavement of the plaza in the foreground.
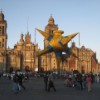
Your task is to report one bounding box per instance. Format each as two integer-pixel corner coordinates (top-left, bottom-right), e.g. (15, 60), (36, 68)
(0, 78), (100, 100)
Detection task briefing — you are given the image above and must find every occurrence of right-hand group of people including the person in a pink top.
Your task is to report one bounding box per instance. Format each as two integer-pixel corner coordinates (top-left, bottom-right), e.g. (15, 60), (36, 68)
(64, 73), (100, 92)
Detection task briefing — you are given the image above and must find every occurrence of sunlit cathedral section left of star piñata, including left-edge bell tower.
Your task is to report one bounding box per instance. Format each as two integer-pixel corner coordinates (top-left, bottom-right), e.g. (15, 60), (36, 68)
(0, 11), (38, 72)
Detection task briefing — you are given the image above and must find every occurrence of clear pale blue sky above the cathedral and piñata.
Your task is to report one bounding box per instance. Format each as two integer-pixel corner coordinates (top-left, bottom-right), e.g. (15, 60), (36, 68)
(0, 0), (100, 62)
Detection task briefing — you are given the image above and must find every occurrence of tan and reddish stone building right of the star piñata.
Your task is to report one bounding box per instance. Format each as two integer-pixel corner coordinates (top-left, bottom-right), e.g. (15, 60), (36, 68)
(67, 42), (98, 73)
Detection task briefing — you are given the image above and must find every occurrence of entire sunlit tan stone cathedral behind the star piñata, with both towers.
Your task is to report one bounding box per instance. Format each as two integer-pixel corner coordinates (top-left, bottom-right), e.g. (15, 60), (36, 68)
(0, 11), (100, 73)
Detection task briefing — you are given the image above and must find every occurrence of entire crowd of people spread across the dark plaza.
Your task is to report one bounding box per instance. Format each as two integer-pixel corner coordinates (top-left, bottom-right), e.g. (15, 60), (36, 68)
(0, 72), (100, 94)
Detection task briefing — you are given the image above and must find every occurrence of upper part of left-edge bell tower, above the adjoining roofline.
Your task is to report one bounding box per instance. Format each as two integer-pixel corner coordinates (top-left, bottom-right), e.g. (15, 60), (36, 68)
(0, 11), (7, 52)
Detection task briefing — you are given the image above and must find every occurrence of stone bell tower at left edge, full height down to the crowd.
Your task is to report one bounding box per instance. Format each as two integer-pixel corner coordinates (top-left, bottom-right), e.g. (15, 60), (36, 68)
(0, 11), (7, 72)
